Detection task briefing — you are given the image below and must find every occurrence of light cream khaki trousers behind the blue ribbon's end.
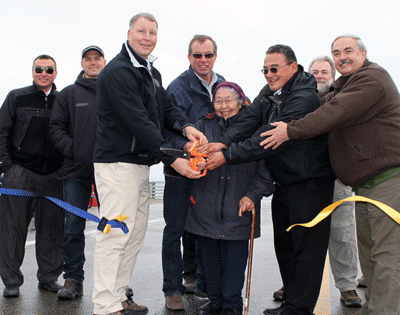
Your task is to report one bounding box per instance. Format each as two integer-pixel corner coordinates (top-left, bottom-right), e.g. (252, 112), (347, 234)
(92, 162), (150, 314)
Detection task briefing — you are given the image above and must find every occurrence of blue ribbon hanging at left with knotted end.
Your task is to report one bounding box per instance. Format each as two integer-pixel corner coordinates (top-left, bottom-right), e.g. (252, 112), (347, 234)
(0, 188), (129, 234)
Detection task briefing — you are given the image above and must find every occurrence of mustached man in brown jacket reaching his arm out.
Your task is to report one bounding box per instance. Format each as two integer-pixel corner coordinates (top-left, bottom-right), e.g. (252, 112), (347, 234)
(260, 34), (400, 315)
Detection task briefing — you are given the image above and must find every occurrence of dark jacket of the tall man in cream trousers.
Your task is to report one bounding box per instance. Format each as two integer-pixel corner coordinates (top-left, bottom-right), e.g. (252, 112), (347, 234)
(93, 43), (189, 165)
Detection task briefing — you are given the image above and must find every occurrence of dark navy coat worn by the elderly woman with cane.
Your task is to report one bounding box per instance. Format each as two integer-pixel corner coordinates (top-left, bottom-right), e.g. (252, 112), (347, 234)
(185, 114), (274, 240)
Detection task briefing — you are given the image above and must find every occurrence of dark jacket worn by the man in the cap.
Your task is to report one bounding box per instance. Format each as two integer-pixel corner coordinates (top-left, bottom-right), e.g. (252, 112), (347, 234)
(50, 71), (97, 179)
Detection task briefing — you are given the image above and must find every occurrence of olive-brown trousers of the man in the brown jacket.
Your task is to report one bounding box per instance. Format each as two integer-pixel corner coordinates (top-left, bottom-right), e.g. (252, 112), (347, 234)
(356, 176), (400, 315)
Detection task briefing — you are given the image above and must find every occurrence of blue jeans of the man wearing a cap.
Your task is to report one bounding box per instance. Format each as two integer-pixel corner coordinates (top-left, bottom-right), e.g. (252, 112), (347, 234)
(62, 178), (94, 283)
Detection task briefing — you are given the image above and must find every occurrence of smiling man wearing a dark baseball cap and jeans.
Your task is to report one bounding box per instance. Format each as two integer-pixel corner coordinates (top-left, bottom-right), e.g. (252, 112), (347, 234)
(50, 46), (106, 300)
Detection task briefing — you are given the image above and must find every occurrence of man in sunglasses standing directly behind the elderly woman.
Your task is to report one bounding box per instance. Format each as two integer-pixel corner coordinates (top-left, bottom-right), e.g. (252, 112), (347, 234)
(162, 35), (225, 310)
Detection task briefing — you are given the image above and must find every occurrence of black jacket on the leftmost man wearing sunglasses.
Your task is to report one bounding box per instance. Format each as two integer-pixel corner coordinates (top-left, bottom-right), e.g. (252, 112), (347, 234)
(0, 84), (62, 175)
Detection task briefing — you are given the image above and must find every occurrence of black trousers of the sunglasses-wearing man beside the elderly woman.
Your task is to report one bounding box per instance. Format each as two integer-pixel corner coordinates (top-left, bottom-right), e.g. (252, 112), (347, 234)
(272, 179), (334, 315)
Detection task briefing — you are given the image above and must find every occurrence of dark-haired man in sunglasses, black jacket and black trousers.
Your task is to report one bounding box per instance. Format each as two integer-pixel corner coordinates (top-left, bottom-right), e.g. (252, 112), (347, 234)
(207, 45), (335, 315)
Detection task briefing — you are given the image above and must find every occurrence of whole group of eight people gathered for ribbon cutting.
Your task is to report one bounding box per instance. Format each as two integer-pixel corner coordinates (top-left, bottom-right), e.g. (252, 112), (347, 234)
(0, 9), (400, 315)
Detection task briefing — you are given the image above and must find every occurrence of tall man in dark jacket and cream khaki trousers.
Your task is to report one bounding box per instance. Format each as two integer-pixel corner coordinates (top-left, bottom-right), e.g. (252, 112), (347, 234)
(93, 13), (207, 315)
